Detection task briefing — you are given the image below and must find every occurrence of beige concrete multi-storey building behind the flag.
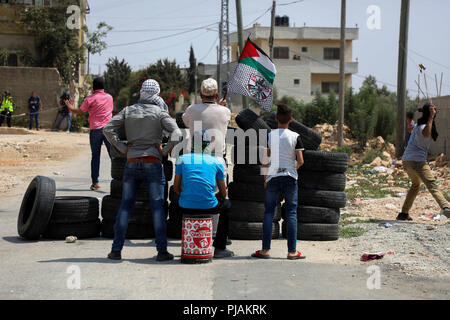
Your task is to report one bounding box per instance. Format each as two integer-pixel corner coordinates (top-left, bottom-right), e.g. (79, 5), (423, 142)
(222, 19), (359, 109)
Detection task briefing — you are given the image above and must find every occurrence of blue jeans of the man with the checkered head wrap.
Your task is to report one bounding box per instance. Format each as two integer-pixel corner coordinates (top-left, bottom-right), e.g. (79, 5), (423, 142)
(112, 162), (167, 253)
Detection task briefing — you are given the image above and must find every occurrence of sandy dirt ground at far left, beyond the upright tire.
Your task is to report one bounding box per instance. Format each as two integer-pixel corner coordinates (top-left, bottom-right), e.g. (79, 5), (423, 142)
(0, 127), (89, 196)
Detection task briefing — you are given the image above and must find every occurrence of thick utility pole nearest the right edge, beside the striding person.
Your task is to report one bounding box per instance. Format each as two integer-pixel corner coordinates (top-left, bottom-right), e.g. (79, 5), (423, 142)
(395, 0), (409, 158)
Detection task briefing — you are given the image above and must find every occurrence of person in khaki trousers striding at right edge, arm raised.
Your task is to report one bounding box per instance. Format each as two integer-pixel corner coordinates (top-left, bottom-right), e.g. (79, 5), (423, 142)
(397, 103), (450, 220)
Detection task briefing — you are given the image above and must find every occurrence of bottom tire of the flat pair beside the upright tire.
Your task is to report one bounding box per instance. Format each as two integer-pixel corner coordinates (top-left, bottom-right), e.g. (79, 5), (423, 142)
(42, 219), (100, 240)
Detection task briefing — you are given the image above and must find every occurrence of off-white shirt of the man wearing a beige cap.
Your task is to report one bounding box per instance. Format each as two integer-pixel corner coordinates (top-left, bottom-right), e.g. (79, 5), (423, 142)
(183, 103), (231, 156)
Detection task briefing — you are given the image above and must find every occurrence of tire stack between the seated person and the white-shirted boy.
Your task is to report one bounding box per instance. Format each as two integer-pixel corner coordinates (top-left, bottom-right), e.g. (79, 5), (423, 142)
(228, 109), (281, 240)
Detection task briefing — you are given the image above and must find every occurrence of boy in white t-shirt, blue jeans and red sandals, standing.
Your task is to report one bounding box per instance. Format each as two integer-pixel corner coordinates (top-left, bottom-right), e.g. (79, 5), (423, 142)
(252, 104), (305, 260)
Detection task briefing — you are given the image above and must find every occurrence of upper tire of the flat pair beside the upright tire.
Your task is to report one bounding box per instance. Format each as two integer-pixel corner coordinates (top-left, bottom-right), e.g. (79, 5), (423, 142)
(49, 196), (99, 223)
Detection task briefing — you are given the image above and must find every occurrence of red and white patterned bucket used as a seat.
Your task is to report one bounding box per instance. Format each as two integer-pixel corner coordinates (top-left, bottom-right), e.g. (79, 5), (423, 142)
(181, 215), (214, 263)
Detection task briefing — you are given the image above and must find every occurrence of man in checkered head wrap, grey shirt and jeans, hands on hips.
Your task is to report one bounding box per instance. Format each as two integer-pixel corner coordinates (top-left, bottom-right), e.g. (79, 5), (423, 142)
(103, 79), (181, 261)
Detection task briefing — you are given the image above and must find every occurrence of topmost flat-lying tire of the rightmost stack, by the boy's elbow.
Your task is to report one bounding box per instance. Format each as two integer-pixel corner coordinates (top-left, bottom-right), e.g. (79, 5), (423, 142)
(300, 151), (348, 173)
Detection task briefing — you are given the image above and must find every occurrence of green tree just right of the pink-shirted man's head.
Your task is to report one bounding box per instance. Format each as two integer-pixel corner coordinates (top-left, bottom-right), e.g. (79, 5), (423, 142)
(103, 57), (131, 100)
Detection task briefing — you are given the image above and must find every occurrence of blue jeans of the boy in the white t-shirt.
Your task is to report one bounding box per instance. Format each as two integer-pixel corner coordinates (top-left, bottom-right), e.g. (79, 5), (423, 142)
(263, 176), (298, 252)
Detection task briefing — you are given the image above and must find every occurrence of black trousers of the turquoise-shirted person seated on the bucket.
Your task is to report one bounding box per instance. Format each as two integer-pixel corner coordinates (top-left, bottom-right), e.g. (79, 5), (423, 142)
(180, 199), (230, 250)
